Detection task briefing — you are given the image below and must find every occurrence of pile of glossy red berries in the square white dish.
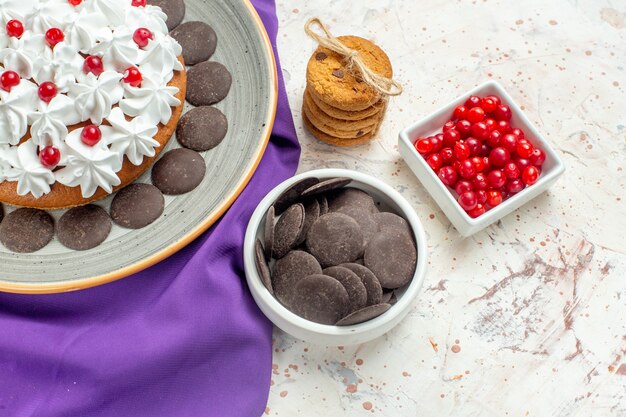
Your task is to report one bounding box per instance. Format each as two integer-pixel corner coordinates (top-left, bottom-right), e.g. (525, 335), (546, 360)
(414, 96), (546, 218)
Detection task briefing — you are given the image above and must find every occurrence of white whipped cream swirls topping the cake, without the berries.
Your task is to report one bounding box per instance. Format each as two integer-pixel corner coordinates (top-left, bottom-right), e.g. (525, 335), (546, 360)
(0, 0), (183, 198)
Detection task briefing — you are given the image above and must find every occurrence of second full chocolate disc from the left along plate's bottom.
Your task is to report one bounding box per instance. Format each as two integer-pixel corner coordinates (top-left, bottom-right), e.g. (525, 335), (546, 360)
(57, 204), (111, 250)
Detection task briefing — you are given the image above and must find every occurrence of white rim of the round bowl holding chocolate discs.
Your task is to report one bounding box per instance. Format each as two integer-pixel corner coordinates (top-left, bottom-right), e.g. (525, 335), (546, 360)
(243, 168), (428, 336)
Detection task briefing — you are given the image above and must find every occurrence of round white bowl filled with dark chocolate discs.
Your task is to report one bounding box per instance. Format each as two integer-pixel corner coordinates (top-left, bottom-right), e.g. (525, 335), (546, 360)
(244, 169), (427, 345)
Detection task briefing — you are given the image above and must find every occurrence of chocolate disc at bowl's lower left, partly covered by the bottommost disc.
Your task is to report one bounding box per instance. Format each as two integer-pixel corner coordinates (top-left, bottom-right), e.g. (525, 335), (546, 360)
(272, 250), (322, 306)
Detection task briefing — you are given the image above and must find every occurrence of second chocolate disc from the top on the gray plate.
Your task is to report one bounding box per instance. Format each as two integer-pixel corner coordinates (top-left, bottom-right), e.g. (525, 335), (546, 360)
(170, 22), (217, 64)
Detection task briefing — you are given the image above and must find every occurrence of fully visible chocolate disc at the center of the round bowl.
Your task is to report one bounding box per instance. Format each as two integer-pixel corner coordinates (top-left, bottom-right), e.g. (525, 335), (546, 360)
(306, 213), (363, 267)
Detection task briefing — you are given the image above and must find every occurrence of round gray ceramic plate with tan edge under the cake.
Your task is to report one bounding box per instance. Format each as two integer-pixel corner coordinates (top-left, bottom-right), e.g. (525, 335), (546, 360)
(0, 0), (278, 293)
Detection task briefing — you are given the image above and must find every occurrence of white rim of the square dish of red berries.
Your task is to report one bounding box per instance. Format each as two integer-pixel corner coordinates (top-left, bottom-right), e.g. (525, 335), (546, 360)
(400, 80), (565, 226)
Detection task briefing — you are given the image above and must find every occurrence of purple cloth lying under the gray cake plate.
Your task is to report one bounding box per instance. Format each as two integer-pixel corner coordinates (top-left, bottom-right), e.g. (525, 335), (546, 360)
(0, 0), (300, 417)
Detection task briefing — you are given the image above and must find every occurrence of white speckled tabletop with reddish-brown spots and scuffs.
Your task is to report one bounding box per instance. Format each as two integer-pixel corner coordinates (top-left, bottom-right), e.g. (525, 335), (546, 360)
(266, 0), (626, 417)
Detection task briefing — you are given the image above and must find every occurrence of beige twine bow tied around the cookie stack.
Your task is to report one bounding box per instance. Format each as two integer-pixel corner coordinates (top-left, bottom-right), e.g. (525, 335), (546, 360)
(304, 17), (402, 97)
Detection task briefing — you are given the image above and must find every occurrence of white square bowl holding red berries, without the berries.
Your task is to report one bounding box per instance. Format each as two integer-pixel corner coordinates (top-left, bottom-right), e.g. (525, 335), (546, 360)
(398, 81), (565, 236)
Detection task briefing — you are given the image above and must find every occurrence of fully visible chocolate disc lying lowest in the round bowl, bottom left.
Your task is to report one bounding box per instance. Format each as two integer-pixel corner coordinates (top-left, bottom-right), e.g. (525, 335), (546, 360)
(292, 275), (350, 324)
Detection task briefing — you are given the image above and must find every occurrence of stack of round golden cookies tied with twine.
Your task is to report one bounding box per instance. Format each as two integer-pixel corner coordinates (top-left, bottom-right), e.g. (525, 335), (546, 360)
(302, 36), (393, 146)
